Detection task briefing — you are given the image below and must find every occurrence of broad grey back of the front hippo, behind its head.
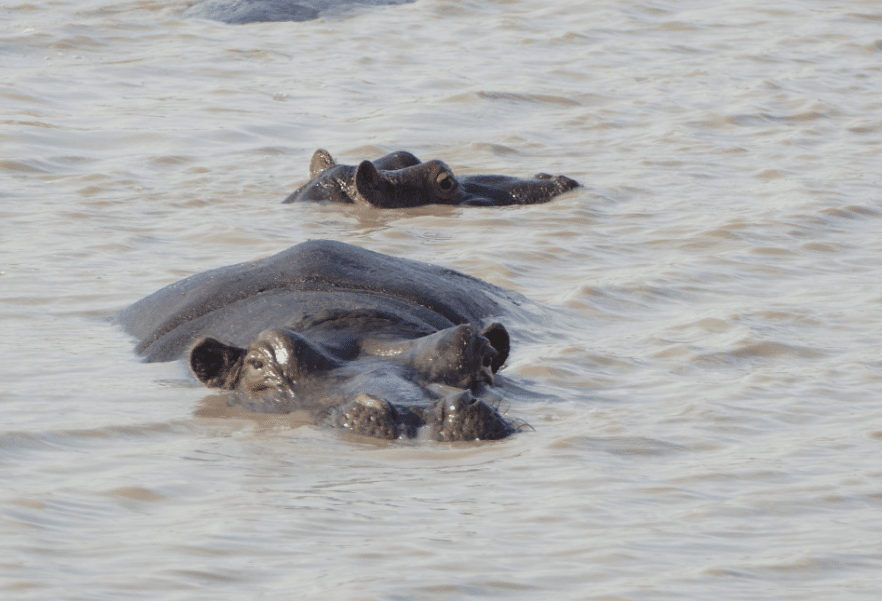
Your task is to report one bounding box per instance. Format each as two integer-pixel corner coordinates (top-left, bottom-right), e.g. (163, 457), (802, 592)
(118, 240), (525, 361)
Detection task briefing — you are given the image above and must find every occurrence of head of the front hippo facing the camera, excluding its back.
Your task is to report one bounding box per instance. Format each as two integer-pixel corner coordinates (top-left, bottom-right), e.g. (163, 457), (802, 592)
(189, 320), (515, 441)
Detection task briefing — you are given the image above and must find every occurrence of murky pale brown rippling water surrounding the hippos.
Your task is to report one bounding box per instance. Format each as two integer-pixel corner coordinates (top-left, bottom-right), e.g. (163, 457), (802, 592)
(0, 0), (882, 600)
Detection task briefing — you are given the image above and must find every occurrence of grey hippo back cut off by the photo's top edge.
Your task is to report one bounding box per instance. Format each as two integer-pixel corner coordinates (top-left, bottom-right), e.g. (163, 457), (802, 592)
(184, 0), (416, 24)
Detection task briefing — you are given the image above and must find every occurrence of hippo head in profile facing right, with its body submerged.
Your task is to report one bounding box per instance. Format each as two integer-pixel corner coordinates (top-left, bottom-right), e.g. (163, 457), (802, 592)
(283, 149), (579, 209)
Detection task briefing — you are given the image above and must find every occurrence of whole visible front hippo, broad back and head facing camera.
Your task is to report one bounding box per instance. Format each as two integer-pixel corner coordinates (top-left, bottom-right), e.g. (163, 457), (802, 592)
(118, 240), (529, 441)
